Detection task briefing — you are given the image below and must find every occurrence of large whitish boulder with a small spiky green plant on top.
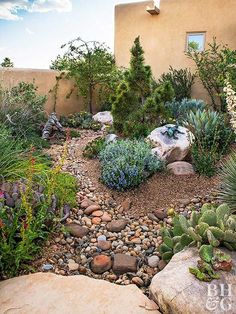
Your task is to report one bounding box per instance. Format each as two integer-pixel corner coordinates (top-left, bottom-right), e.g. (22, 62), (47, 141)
(147, 124), (190, 163)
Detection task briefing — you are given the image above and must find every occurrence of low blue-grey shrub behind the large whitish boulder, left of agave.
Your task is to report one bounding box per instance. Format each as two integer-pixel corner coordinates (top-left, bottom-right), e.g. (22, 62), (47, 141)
(166, 98), (206, 121)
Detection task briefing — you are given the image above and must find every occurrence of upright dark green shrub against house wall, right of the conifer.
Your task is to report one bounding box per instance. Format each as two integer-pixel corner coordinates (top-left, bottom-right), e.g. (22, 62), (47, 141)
(159, 67), (196, 101)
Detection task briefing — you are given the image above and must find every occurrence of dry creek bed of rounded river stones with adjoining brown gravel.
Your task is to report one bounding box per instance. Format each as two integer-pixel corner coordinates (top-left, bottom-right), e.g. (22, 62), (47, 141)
(33, 131), (217, 294)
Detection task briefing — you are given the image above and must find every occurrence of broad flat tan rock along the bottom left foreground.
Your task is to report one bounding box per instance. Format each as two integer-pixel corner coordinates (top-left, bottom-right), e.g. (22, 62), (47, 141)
(0, 273), (159, 314)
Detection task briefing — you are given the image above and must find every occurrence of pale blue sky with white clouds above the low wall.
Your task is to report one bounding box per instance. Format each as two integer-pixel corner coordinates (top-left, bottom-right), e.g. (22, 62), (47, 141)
(0, 0), (145, 68)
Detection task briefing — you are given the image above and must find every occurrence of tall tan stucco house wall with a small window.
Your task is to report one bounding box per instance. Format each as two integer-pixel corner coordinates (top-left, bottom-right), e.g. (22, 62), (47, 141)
(115, 0), (236, 101)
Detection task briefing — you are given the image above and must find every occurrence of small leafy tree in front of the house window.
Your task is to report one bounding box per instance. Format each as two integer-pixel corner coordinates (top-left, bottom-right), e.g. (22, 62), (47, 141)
(186, 38), (236, 112)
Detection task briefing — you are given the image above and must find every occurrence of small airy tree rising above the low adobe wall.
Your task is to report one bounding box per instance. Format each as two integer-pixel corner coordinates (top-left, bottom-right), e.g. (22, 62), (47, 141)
(51, 38), (116, 113)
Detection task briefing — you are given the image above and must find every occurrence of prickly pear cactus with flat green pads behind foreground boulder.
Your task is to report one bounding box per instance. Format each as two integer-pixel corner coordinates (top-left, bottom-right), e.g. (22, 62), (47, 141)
(159, 204), (236, 262)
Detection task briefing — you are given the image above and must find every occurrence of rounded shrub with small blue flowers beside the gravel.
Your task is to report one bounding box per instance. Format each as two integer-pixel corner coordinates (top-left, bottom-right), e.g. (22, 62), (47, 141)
(100, 140), (163, 191)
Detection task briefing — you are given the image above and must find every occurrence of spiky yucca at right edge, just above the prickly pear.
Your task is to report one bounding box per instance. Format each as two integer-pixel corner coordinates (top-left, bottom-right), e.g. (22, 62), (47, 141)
(219, 152), (236, 213)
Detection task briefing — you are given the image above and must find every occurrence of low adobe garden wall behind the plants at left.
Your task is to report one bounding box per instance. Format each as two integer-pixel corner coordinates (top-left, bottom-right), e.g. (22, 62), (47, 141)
(0, 68), (89, 115)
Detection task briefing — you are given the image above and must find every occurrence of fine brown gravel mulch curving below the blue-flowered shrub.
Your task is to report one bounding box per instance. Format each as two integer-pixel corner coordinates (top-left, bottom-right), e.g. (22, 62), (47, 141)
(76, 131), (219, 214)
